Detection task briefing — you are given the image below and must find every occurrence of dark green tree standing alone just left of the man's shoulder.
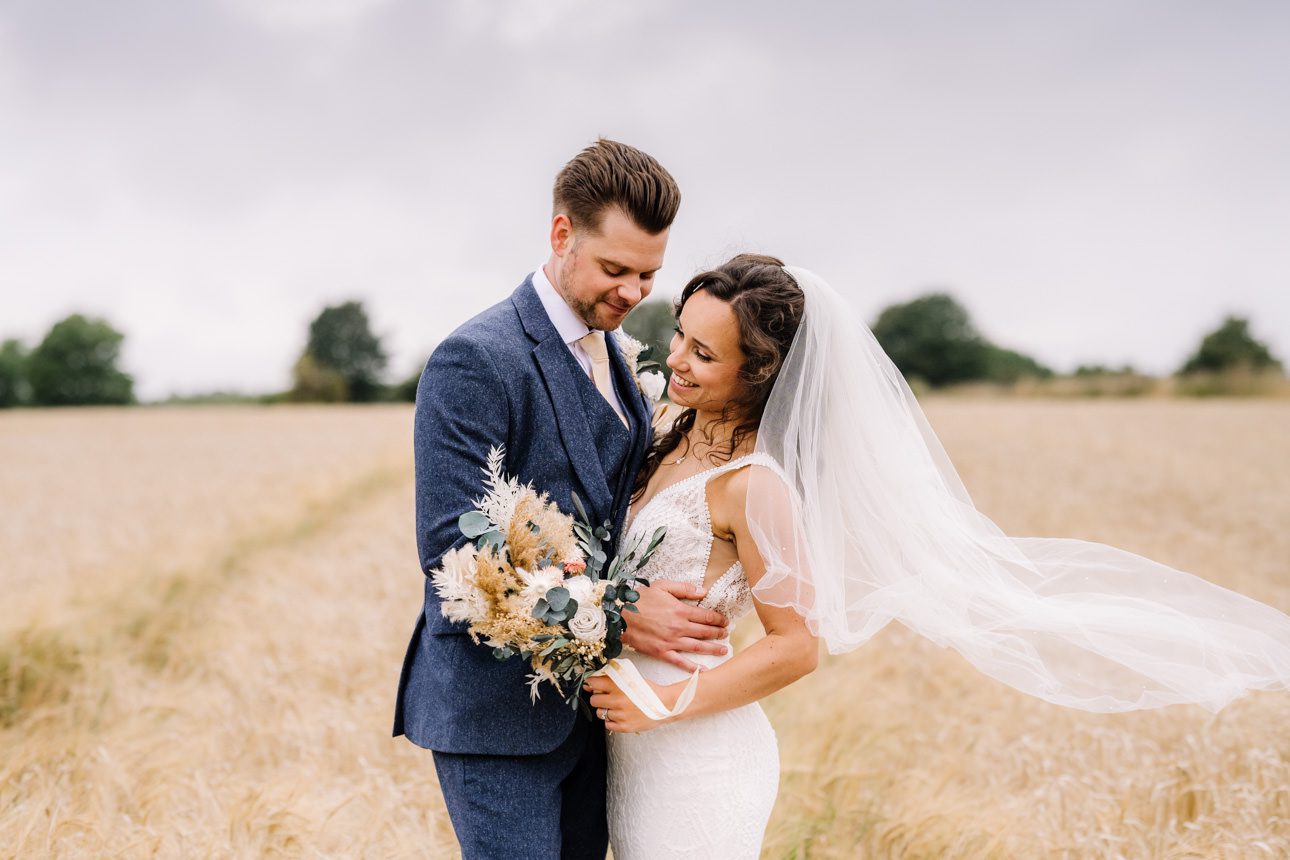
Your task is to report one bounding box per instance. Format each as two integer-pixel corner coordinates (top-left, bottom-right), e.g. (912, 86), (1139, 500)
(292, 302), (387, 402)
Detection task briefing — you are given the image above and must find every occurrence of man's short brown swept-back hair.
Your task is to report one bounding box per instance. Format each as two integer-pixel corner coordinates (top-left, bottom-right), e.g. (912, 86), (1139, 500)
(551, 138), (681, 236)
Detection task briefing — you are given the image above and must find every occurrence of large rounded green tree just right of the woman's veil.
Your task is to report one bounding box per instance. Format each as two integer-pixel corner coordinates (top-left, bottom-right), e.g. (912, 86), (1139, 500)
(872, 293), (989, 387)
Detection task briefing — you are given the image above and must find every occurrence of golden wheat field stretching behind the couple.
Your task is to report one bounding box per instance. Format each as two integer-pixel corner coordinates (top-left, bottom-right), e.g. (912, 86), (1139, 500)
(0, 398), (1290, 857)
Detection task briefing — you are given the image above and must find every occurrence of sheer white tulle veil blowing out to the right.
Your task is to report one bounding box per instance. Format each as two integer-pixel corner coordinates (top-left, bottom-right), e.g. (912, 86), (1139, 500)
(747, 267), (1290, 712)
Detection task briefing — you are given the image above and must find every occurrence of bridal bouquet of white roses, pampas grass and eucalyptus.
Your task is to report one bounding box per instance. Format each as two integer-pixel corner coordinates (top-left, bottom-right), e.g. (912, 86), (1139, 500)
(431, 447), (666, 707)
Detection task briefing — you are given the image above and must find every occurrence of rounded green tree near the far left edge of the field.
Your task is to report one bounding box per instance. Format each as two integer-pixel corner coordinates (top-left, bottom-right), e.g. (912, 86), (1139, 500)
(27, 313), (134, 406)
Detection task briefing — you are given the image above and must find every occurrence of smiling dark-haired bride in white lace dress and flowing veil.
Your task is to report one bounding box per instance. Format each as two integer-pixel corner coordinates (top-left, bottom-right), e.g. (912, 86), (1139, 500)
(587, 254), (1290, 860)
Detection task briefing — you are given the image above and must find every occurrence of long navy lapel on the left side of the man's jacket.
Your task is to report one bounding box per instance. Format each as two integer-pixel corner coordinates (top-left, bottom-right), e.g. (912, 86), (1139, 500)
(511, 277), (614, 525)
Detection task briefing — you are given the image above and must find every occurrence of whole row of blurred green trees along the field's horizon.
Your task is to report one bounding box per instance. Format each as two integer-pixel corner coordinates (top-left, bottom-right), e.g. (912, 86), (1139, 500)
(0, 293), (1285, 407)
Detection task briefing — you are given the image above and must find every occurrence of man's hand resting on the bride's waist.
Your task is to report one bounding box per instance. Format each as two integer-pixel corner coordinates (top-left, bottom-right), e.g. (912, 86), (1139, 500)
(623, 579), (729, 672)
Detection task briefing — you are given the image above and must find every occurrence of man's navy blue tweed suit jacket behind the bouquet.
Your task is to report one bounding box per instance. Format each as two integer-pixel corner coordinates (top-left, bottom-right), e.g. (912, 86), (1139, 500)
(393, 277), (651, 756)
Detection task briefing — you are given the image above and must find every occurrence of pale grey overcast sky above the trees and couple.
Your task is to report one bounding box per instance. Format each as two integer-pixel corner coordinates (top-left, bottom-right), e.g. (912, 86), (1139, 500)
(0, 0), (1290, 398)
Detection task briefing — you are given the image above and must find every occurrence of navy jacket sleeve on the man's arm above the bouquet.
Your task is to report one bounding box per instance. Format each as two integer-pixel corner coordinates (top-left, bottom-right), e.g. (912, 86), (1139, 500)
(413, 335), (511, 575)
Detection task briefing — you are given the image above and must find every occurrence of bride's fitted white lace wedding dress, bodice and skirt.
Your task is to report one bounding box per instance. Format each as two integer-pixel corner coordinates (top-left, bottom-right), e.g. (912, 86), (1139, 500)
(609, 454), (779, 860)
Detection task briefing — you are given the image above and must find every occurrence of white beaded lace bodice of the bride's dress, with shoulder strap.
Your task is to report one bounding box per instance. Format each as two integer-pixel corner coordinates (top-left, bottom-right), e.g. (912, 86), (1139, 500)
(627, 454), (775, 628)
